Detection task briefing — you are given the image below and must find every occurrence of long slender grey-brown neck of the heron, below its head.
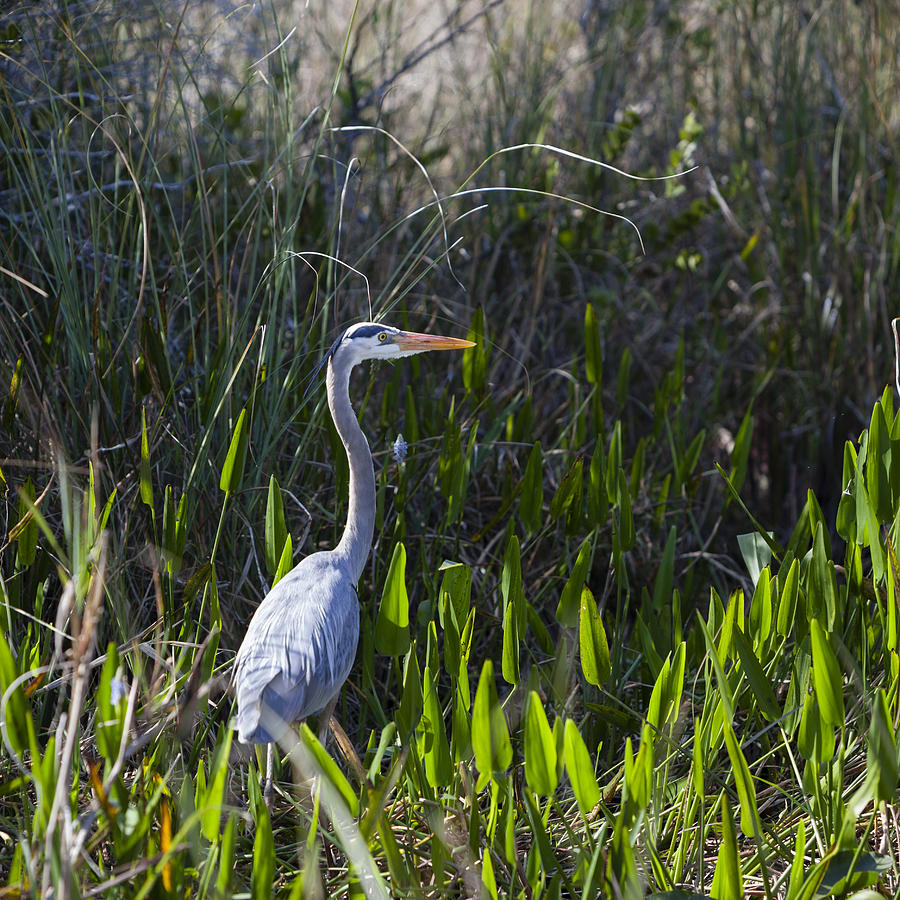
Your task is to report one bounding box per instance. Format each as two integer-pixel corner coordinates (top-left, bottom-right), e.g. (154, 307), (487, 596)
(325, 360), (375, 582)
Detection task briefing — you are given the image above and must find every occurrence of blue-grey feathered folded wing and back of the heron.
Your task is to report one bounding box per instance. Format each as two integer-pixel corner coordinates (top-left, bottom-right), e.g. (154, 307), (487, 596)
(235, 553), (359, 743)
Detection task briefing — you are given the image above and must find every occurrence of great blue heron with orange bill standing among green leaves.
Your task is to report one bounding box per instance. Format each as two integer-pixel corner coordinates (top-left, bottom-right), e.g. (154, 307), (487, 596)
(234, 322), (474, 744)
